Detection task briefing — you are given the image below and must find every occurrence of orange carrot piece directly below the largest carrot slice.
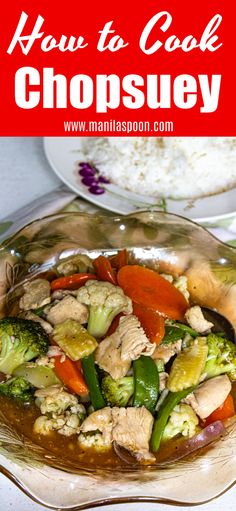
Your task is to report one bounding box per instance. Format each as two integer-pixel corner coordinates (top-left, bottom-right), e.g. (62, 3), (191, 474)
(133, 303), (165, 344)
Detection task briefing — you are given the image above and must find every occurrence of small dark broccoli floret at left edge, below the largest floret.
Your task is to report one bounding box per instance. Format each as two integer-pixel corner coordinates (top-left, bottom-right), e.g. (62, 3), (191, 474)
(0, 376), (34, 403)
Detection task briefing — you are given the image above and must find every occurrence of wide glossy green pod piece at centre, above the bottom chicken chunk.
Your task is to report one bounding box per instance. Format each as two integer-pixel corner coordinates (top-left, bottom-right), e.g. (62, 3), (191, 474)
(133, 355), (159, 413)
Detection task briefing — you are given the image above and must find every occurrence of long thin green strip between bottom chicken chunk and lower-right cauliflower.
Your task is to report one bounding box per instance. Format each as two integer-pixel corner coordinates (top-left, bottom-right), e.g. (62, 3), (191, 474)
(151, 387), (195, 452)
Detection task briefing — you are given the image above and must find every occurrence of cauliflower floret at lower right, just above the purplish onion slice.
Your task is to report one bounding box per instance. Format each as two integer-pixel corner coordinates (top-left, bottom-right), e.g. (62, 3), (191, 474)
(162, 404), (198, 440)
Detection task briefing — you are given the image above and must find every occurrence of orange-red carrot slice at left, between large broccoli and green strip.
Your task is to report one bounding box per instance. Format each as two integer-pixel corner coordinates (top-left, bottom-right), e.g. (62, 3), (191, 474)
(54, 355), (88, 396)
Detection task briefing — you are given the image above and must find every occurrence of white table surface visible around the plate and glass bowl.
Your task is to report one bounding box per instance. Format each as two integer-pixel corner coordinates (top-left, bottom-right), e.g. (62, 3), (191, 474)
(0, 137), (236, 511)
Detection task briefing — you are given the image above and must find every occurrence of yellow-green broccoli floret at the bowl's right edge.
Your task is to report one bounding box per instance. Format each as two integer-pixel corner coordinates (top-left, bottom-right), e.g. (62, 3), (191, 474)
(203, 334), (236, 380)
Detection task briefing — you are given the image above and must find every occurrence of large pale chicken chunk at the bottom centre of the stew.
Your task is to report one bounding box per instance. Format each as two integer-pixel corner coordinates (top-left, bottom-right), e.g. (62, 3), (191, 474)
(112, 406), (155, 463)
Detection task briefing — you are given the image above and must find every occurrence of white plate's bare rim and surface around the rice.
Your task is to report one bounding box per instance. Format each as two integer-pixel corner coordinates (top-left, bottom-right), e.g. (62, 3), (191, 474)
(44, 137), (236, 221)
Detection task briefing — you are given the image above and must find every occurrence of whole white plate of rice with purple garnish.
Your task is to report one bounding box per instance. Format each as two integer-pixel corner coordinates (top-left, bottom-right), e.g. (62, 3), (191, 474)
(44, 137), (236, 221)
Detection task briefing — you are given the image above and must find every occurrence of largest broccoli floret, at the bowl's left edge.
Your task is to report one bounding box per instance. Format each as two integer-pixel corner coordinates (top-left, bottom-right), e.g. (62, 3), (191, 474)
(0, 317), (49, 375)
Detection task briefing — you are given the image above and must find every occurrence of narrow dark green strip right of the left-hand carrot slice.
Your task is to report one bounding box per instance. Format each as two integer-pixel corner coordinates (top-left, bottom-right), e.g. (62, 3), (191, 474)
(81, 353), (106, 410)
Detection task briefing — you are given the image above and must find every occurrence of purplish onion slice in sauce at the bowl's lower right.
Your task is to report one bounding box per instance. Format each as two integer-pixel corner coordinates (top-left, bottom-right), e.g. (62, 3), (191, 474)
(157, 421), (227, 466)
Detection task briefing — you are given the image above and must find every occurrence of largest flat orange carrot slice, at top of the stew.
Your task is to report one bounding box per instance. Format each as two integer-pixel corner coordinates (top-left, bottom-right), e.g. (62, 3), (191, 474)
(117, 265), (189, 319)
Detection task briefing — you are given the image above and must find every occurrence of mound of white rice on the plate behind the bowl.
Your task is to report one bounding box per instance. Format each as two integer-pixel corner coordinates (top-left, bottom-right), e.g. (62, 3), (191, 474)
(82, 137), (236, 199)
